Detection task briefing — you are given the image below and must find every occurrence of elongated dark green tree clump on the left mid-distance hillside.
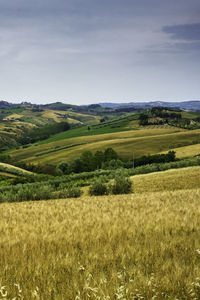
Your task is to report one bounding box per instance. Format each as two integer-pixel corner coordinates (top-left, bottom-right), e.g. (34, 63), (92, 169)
(18, 122), (70, 145)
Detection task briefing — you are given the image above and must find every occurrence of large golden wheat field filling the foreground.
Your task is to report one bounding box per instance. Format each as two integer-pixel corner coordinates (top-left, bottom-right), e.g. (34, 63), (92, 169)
(0, 167), (200, 300)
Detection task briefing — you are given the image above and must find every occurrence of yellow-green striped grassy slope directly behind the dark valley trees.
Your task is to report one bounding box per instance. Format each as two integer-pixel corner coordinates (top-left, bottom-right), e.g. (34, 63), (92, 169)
(10, 127), (200, 163)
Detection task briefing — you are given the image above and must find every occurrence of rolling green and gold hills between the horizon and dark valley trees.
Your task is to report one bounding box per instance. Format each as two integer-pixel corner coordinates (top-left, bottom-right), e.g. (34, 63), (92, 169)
(0, 102), (200, 165)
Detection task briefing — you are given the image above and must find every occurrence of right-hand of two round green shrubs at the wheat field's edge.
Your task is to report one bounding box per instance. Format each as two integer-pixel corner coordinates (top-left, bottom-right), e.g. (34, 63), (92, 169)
(109, 172), (132, 195)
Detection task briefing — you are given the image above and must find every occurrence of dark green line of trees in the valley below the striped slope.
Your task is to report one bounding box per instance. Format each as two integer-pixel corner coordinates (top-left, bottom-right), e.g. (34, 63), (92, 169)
(0, 148), (176, 176)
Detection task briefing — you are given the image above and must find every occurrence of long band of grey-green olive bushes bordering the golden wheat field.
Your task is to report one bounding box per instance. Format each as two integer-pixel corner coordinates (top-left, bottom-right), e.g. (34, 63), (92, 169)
(0, 157), (200, 202)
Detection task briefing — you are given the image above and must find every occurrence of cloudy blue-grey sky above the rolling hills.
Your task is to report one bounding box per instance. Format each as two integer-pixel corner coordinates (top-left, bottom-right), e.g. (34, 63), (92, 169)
(0, 0), (200, 105)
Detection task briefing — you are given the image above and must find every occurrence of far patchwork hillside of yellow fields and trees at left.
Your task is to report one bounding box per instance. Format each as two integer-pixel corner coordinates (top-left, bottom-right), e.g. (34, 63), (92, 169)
(0, 104), (106, 150)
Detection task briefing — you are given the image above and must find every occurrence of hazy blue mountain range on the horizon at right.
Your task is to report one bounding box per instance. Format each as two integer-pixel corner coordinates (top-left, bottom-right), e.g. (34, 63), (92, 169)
(99, 100), (200, 111)
